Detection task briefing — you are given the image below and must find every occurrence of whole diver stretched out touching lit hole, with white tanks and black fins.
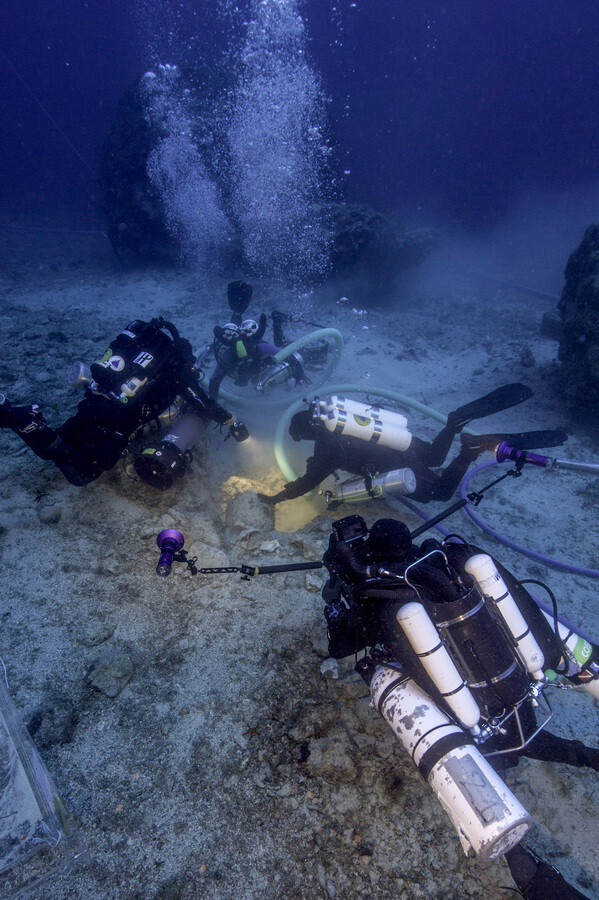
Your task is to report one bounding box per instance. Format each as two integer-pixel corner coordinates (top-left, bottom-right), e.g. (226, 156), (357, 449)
(258, 383), (567, 509)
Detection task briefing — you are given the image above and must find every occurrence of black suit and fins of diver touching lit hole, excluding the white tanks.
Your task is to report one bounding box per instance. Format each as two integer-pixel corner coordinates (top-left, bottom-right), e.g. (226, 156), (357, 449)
(258, 383), (567, 505)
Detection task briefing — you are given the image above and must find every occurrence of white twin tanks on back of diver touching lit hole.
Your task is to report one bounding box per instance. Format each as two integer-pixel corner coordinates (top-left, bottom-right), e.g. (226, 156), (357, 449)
(315, 394), (412, 450)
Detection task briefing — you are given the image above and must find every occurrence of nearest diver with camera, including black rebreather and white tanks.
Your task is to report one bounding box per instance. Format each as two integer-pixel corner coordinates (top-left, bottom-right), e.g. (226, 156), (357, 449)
(322, 508), (599, 900)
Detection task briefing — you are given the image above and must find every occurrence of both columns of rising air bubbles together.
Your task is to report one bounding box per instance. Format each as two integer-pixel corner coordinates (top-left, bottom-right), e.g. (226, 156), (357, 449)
(142, 0), (332, 286)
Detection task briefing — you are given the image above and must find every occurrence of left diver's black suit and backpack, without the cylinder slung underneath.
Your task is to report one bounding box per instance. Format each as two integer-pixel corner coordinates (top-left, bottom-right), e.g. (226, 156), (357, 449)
(0, 318), (233, 487)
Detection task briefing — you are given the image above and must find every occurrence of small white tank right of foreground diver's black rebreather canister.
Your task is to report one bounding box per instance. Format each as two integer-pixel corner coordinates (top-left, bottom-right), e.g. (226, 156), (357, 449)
(464, 553), (545, 681)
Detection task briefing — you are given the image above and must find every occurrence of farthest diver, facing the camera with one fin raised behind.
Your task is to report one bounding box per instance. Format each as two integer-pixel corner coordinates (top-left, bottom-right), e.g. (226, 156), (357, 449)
(208, 281), (309, 400)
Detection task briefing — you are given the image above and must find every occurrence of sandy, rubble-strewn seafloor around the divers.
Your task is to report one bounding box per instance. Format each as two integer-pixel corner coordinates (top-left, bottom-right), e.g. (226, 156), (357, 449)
(0, 220), (599, 900)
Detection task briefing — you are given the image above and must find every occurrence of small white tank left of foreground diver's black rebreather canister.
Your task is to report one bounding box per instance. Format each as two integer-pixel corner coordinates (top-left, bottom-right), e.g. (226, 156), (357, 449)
(396, 601), (480, 734)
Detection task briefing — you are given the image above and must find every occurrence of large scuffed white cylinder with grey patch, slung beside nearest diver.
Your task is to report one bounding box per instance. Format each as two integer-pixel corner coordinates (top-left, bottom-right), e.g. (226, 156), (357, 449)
(370, 666), (532, 862)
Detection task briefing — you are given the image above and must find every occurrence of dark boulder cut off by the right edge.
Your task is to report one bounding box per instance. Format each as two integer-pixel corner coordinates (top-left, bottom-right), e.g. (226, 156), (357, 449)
(559, 225), (599, 429)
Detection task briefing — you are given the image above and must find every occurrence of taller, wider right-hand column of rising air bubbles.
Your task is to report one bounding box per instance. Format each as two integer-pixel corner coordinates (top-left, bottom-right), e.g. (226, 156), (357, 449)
(229, 0), (329, 282)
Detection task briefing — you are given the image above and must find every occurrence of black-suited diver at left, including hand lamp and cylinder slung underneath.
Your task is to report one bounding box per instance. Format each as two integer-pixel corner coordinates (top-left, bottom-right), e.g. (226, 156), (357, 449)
(0, 317), (248, 490)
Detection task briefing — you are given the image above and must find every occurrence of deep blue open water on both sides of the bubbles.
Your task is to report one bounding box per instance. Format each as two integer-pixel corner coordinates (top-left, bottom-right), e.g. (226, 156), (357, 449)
(0, 0), (599, 227)
